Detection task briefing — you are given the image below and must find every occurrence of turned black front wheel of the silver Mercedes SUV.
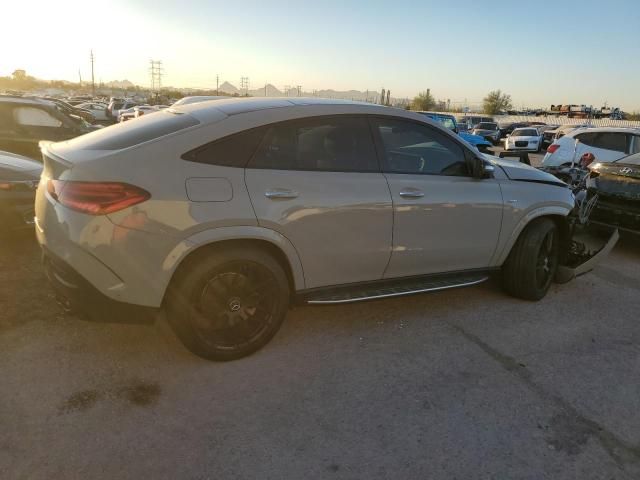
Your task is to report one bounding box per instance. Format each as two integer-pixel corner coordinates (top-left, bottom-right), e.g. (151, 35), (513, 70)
(502, 218), (559, 301)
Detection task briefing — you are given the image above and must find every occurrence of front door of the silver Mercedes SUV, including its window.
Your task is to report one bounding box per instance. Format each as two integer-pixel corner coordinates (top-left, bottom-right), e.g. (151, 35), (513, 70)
(373, 118), (503, 278)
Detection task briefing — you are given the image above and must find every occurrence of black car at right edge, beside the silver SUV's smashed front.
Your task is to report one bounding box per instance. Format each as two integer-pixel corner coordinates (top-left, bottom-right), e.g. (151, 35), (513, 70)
(587, 153), (640, 234)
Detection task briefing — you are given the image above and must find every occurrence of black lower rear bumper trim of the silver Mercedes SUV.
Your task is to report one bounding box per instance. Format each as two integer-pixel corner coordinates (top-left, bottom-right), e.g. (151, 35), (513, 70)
(42, 247), (159, 323)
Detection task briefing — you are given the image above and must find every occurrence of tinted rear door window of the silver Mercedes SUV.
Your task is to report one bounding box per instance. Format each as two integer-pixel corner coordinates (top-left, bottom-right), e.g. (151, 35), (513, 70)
(249, 117), (379, 172)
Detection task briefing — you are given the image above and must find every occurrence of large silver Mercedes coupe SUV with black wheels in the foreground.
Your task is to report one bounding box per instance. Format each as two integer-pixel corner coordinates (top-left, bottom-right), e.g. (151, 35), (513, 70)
(36, 98), (616, 360)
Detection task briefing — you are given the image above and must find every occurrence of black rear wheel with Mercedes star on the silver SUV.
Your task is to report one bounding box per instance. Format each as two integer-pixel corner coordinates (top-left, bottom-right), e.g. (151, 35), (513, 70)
(165, 247), (289, 361)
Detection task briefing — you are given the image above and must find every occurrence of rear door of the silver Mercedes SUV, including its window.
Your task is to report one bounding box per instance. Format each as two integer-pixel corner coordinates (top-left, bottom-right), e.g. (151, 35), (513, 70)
(245, 116), (393, 288)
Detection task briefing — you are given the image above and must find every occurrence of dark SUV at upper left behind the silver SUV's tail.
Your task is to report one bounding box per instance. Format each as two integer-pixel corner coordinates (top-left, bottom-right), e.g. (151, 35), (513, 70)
(0, 95), (99, 160)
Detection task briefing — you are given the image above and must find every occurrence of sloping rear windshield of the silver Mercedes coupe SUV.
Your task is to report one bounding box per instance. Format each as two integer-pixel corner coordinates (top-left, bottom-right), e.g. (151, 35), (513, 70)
(62, 111), (200, 150)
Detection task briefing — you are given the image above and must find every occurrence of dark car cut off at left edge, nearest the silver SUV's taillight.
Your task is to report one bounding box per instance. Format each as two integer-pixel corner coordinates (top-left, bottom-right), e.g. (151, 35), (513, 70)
(0, 151), (42, 235)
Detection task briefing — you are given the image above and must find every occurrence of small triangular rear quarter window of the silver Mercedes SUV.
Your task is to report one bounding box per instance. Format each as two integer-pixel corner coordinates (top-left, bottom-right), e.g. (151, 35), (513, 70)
(182, 128), (266, 168)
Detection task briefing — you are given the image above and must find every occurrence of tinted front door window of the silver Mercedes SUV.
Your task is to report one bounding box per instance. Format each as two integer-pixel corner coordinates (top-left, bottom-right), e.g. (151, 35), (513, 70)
(375, 119), (469, 176)
